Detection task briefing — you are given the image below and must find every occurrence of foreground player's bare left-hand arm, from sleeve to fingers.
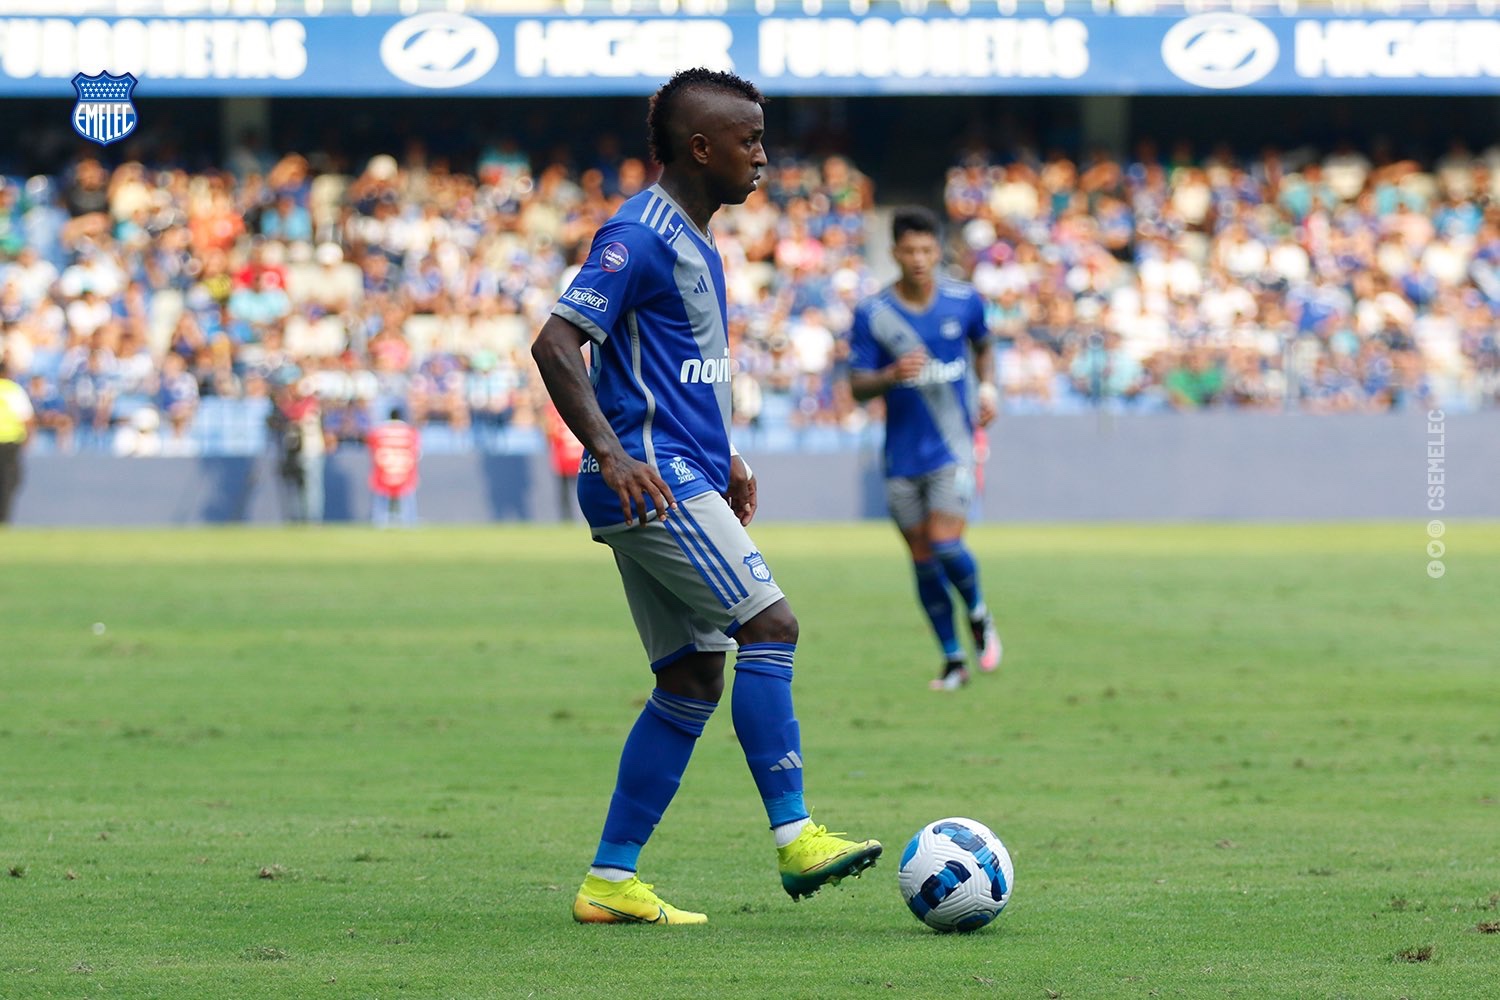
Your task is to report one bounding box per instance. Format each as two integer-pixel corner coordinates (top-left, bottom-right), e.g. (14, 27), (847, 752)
(531, 313), (677, 525)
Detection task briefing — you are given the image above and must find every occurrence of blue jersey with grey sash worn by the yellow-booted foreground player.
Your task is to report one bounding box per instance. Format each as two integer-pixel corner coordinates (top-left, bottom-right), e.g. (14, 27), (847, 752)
(552, 184), (734, 531)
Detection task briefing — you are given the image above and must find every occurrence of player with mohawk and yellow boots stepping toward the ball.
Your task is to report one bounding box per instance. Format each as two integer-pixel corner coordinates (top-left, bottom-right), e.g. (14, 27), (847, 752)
(531, 69), (881, 924)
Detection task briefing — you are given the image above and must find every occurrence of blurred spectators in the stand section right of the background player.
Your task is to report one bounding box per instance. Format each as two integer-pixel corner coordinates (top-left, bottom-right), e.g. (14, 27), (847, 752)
(945, 142), (1500, 412)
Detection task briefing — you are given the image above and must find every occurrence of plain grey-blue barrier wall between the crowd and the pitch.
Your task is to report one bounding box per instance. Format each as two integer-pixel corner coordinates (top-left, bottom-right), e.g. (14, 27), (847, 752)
(15, 412), (1500, 526)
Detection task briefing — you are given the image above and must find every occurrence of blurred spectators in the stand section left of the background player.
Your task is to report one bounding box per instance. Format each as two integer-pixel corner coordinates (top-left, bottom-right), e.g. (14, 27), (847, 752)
(0, 144), (873, 454)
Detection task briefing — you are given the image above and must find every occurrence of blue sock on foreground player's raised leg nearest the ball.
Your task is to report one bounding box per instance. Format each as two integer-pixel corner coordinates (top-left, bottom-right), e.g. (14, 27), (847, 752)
(729, 642), (807, 829)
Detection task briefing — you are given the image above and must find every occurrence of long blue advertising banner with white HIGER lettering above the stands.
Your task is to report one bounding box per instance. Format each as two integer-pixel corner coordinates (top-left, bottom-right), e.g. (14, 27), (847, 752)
(0, 12), (1500, 99)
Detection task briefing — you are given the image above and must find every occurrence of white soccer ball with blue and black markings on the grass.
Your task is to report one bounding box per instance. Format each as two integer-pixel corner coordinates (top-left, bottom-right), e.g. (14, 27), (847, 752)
(899, 817), (1016, 931)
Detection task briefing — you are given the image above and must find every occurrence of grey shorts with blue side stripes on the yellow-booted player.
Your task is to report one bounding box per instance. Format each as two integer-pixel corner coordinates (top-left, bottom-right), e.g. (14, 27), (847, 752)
(597, 493), (783, 670)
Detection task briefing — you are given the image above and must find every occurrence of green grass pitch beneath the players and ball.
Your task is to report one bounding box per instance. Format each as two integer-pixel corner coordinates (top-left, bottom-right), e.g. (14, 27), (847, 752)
(0, 522), (1500, 1000)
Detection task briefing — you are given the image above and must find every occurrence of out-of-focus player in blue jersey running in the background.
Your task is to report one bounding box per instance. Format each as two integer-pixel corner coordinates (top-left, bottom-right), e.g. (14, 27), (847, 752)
(849, 208), (1001, 691)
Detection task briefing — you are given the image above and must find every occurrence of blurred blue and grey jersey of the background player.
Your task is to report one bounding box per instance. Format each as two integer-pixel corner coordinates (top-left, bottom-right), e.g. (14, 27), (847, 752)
(849, 279), (990, 477)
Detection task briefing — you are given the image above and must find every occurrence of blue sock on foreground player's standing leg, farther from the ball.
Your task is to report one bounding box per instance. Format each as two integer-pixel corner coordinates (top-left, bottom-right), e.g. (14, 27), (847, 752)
(594, 688), (714, 871)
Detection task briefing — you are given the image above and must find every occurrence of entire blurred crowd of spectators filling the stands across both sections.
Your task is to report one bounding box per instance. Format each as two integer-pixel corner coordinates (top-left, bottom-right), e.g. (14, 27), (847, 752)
(0, 132), (1500, 454)
